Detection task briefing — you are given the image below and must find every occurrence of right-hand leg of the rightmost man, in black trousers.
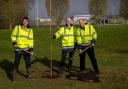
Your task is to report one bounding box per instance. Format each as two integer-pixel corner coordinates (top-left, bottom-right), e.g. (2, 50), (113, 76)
(87, 47), (99, 74)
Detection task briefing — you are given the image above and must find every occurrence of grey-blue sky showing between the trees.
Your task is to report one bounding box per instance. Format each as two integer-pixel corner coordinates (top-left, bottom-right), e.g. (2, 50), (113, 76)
(29, 0), (120, 18)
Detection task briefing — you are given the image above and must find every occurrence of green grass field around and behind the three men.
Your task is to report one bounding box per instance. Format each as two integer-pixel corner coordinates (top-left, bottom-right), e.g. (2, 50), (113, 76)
(0, 25), (128, 89)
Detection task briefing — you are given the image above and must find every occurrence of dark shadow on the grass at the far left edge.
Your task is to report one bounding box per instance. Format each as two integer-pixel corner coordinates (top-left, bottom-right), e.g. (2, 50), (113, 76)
(0, 59), (13, 81)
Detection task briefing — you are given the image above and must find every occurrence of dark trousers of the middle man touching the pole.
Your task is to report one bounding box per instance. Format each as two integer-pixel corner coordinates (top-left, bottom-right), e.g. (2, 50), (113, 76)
(60, 49), (74, 71)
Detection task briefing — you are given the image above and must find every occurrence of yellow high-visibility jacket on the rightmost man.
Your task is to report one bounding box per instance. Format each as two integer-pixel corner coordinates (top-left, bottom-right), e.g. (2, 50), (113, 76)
(77, 24), (97, 46)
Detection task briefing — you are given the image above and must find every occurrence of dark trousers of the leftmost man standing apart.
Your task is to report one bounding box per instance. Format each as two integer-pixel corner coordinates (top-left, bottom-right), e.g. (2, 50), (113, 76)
(14, 51), (31, 70)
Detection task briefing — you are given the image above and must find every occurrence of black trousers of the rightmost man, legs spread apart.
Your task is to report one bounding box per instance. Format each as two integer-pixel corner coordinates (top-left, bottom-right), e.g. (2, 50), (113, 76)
(79, 46), (99, 72)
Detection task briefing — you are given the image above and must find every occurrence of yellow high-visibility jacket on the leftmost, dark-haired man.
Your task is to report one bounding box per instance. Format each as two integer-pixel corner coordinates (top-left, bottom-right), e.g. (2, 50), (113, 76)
(11, 25), (33, 49)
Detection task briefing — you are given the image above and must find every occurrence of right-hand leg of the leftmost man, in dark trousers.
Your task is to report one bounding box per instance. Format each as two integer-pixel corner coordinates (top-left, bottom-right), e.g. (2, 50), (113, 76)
(23, 53), (32, 78)
